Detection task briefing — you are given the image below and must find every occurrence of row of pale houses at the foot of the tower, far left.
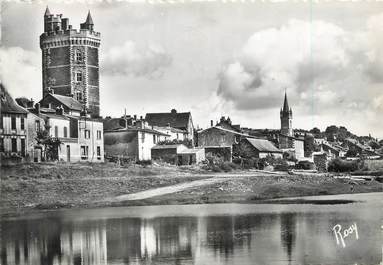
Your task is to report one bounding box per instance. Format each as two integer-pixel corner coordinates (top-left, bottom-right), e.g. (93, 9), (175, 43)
(0, 85), (104, 163)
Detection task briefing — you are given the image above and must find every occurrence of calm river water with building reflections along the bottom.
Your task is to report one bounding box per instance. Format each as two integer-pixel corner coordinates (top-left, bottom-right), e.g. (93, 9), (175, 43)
(0, 193), (383, 265)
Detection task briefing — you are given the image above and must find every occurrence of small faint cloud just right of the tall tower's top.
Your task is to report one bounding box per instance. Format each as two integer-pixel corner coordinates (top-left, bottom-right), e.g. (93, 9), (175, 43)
(101, 41), (172, 78)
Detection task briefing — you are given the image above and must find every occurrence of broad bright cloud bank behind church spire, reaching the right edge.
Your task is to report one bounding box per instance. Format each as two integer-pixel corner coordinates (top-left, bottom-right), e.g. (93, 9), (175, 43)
(216, 14), (383, 135)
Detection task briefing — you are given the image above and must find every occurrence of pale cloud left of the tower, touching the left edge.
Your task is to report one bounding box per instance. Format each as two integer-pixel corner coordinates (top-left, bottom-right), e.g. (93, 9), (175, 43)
(0, 47), (42, 98)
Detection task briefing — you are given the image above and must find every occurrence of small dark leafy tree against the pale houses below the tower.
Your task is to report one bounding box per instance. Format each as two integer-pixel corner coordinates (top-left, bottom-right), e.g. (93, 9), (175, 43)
(36, 129), (62, 161)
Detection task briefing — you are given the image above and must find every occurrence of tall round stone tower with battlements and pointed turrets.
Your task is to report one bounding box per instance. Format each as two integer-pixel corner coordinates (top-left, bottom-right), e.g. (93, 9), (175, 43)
(40, 7), (101, 117)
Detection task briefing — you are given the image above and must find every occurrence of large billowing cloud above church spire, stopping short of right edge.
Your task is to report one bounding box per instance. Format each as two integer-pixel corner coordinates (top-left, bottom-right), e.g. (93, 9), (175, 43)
(217, 20), (352, 110)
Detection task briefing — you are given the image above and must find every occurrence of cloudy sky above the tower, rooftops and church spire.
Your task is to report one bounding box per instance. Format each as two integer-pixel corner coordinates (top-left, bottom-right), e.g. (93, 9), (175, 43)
(0, 0), (383, 138)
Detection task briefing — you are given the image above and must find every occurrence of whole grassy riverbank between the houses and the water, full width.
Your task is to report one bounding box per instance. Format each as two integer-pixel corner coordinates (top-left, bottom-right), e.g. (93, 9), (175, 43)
(0, 163), (383, 216)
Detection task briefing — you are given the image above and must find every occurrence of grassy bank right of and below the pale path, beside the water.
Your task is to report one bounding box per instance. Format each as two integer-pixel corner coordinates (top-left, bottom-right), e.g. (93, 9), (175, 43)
(130, 174), (383, 205)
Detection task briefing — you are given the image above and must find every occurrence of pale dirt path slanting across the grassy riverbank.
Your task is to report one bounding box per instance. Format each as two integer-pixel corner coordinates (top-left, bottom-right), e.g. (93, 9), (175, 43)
(111, 175), (232, 201)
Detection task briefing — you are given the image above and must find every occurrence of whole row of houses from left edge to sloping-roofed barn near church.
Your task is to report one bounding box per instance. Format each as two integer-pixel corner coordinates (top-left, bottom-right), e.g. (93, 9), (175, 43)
(0, 82), (288, 164)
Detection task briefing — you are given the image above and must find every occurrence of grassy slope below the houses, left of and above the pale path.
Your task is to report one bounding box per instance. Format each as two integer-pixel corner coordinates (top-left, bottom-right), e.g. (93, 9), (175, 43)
(0, 163), (207, 215)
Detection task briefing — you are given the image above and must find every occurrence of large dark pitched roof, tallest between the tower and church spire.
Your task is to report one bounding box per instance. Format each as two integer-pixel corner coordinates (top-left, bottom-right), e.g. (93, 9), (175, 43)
(145, 111), (191, 129)
